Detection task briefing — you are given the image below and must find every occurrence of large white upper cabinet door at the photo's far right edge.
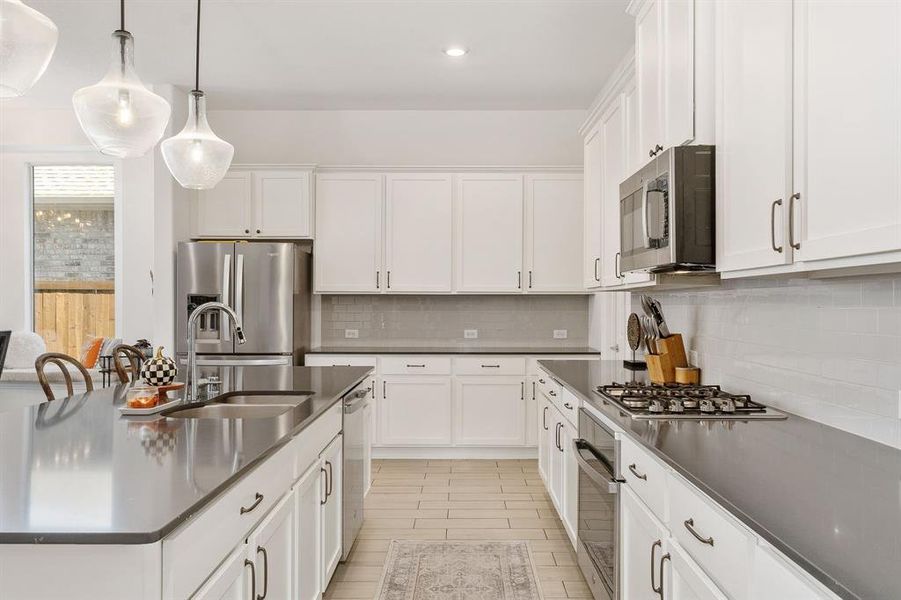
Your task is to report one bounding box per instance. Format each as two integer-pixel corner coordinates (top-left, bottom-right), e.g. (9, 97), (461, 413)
(789, 0), (901, 261)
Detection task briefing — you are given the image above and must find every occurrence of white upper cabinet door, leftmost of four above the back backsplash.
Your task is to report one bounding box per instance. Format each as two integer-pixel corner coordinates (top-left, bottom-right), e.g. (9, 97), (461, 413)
(313, 173), (383, 292)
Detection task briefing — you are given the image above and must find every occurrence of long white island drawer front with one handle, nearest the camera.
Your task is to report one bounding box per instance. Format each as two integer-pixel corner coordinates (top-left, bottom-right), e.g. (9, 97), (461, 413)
(163, 444), (293, 598)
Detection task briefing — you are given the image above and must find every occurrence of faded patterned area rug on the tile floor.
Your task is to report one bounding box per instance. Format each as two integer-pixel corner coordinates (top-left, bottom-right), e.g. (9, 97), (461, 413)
(377, 540), (541, 600)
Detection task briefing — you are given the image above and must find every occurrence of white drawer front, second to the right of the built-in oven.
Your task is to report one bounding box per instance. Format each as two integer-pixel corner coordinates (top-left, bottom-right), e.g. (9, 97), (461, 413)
(669, 474), (755, 600)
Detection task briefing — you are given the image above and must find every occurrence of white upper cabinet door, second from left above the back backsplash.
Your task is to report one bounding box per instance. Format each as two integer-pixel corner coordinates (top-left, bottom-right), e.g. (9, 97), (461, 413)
(385, 173), (453, 292)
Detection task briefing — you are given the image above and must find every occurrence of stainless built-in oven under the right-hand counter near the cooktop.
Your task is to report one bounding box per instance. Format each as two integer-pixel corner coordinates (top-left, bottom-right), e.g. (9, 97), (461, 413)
(573, 408), (621, 600)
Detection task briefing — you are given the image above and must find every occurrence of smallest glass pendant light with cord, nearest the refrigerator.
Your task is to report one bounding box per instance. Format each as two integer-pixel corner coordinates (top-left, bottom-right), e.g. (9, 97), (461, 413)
(160, 0), (235, 190)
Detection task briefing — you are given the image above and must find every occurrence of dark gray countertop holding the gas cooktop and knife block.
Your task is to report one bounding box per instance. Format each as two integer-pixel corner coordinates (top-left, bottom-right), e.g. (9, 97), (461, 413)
(539, 360), (901, 600)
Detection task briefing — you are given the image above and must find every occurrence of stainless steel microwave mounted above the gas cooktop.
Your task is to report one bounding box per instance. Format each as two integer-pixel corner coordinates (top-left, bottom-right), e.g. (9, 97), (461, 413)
(619, 146), (716, 273)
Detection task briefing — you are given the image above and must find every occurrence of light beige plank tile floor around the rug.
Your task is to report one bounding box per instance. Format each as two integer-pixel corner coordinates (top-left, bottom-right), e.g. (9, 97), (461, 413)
(325, 460), (591, 600)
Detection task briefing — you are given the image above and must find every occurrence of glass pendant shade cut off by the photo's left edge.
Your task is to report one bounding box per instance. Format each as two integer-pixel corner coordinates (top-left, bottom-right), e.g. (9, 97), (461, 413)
(0, 0), (59, 98)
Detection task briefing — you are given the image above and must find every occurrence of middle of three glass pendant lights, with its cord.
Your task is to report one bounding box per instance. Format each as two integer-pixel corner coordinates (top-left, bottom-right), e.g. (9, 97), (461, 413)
(72, 0), (172, 158)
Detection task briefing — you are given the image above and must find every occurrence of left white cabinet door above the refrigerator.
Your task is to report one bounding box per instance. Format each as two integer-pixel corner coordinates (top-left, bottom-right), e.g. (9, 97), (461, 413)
(191, 171), (253, 238)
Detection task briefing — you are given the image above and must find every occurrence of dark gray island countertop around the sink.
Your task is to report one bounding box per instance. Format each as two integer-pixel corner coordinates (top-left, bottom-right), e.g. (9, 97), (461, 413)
(0, 367), (371, 544)
